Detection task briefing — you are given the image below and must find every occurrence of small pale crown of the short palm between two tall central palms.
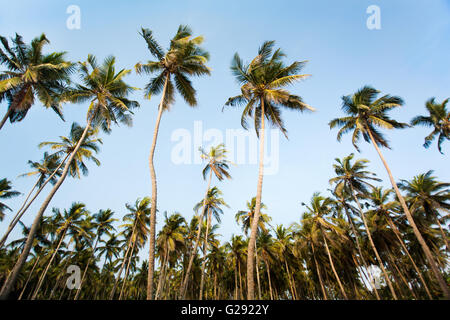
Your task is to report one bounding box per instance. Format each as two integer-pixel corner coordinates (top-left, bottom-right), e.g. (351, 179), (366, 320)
(199, 143), (231, 181)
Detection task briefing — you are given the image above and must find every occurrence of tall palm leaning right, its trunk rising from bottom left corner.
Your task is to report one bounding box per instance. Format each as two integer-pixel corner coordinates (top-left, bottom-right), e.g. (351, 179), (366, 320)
(0, 55), (139, 299)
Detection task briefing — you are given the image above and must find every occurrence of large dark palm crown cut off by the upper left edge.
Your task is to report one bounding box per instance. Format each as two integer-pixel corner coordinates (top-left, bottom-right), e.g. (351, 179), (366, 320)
(0, 33), (74, 130)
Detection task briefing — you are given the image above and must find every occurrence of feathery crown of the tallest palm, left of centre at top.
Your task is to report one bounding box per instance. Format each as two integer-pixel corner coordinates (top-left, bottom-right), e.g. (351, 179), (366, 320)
(135, 25), (210, 110)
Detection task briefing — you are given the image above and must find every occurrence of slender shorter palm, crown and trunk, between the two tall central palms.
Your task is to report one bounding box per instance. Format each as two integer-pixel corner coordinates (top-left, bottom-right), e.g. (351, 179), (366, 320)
(180, 144), (231, 298)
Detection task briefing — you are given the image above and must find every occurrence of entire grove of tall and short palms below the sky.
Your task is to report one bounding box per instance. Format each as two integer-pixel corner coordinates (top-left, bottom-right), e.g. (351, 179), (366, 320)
(0, 26), (450, 300)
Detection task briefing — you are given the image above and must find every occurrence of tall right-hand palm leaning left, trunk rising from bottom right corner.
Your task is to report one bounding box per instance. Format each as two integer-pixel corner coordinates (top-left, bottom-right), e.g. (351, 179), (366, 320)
(329, 86), (450, 299)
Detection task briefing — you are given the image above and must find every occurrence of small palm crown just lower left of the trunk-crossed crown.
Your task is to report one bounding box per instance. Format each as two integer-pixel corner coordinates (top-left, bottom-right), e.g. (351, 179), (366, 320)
(20, 152), (62, 188)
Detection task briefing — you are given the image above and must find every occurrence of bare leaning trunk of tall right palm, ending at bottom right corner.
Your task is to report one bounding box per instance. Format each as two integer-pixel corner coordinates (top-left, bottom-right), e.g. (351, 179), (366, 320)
(367, 129), (450, 300)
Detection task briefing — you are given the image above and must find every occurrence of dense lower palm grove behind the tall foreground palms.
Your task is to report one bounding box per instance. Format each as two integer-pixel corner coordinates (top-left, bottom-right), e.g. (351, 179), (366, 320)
(0, 150), (450, 300)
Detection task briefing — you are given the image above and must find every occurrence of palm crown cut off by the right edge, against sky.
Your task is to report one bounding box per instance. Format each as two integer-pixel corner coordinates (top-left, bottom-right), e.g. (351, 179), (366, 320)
(411, 98), (450, 153)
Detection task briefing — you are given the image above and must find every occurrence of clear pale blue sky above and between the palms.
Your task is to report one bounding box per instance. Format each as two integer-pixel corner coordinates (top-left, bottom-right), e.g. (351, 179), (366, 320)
(0, 0), (450, 257)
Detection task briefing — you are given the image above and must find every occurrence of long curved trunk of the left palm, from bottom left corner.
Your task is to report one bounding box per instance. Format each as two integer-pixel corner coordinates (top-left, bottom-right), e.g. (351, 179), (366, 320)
(0, 119), (92, 300)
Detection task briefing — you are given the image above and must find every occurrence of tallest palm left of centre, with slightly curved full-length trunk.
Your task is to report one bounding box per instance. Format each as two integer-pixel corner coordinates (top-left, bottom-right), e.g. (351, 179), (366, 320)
(135, 25), (210, 300)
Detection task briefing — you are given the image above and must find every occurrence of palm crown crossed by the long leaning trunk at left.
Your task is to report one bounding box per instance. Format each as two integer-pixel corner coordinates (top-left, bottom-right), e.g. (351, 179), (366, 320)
(39, 122), (103, 178)
